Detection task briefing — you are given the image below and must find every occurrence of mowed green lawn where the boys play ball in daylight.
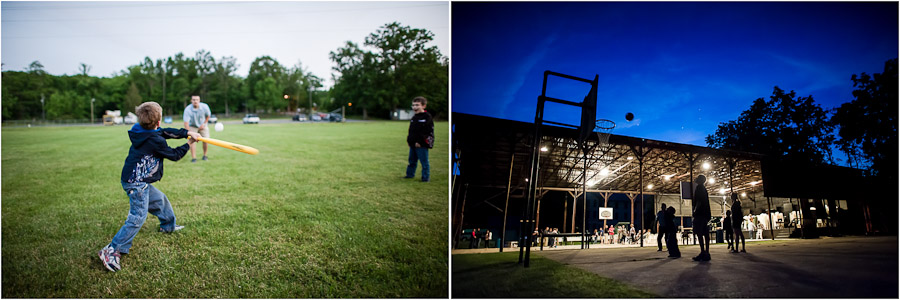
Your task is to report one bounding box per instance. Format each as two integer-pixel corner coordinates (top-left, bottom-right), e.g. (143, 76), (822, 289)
(0, 121), (449, 298)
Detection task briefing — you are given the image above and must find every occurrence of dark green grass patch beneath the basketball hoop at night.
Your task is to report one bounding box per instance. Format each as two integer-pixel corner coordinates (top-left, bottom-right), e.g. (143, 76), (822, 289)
(451, 251), (656, 298)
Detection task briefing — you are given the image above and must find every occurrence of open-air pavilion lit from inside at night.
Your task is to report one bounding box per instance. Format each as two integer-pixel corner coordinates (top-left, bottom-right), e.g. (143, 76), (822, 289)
(451, 113), (871, 247)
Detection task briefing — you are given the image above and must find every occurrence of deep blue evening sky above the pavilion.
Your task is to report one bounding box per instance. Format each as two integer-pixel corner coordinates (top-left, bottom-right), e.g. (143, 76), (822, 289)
(451, 2), (898, 151)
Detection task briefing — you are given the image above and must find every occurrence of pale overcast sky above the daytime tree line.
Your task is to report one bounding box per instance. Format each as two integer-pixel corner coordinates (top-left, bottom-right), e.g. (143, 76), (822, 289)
(0, 1), (450, 87)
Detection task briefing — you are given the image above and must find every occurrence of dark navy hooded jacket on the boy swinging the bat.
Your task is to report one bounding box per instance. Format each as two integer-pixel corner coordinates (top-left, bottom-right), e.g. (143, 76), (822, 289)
(122, 124), (190, 183)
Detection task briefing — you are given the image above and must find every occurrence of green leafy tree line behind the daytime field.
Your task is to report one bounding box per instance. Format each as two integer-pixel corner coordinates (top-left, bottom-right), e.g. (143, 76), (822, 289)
(0, 22), (449, 120)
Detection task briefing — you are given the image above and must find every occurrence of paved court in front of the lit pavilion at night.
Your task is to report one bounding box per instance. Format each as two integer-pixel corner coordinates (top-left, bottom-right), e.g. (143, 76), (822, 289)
(528, 237), (898, 298)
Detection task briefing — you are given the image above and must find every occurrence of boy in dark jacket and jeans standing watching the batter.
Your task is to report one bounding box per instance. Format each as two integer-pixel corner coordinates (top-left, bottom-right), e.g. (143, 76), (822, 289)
(404, 96), (434, 182)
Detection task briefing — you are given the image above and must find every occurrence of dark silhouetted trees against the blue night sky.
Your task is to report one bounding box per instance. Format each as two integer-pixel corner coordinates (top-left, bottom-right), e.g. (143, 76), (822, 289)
(706, 58), (900, 180)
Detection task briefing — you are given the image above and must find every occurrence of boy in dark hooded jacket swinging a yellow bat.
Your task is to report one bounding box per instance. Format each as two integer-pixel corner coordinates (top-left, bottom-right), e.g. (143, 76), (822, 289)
(97, 102), (200, 272)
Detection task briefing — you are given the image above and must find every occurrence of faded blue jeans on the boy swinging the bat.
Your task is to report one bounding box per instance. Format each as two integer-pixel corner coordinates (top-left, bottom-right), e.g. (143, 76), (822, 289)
(109, 182), (175, 253)
